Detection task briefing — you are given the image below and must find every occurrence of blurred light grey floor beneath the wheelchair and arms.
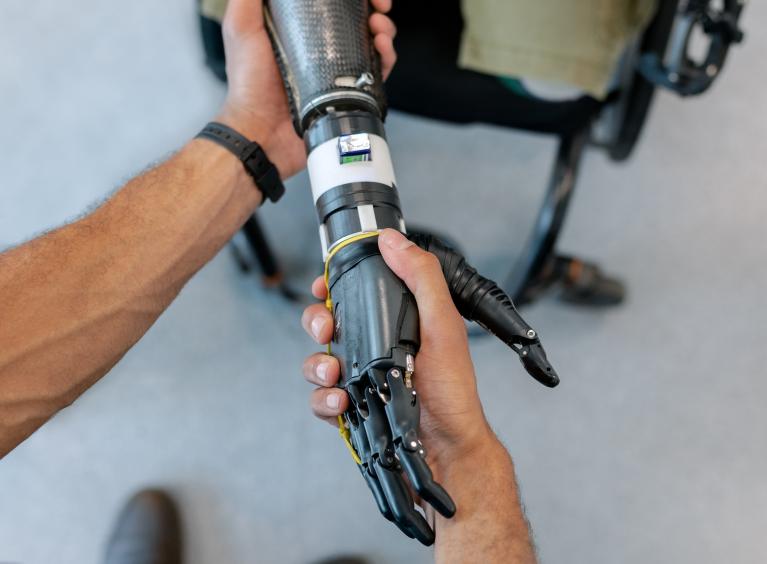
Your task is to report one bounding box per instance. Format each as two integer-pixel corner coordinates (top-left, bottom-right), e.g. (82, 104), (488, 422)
(0, 0), (767, 564)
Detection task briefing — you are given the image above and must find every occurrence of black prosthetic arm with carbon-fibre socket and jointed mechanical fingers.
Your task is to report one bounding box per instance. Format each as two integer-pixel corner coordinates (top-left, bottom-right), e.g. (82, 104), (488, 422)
(266, 0), (559, 545)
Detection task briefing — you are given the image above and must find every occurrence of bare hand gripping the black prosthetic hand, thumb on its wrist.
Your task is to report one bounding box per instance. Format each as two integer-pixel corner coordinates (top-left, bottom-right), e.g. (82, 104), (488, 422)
(302, 229), (497, 478)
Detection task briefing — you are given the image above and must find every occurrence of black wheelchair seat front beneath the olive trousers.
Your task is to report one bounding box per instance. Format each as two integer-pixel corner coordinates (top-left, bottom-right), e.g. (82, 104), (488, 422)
(386, 0), (601, 134)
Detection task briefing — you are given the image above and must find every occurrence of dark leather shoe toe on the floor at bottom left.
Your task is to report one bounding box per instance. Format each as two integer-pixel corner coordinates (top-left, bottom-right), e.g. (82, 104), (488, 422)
(104, 490), (181, 564)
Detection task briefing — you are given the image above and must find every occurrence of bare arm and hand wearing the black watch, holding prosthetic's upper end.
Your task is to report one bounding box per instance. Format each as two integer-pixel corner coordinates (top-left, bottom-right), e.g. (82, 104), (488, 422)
(0, 0), (396, 458)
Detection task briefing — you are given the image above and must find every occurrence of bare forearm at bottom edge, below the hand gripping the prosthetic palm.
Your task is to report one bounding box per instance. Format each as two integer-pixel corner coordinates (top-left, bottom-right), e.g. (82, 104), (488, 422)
(435, 433), (536, 564)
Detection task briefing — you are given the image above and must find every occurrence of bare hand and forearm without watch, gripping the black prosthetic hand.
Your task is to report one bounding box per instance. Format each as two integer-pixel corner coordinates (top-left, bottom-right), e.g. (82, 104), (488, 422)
(302, 229), (536, 564)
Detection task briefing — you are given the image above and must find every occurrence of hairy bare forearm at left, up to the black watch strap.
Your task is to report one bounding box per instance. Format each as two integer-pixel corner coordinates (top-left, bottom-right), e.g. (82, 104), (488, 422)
(0, 140), (261, 457)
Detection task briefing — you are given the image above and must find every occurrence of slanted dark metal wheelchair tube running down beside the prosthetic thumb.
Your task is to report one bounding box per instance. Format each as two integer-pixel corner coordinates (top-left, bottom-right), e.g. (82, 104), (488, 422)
(504, 128), (590, 305)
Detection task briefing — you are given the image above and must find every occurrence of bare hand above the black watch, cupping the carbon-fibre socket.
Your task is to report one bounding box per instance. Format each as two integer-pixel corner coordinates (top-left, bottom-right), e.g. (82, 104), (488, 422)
(217, 0), (396, 178)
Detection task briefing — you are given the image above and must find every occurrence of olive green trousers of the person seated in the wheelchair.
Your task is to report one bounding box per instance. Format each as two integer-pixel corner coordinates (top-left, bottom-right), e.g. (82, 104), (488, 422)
(202, 0), (658, 99)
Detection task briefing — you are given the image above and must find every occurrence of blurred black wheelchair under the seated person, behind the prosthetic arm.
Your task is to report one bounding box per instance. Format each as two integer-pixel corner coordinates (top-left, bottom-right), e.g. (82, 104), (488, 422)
(200, 0), (744, 307)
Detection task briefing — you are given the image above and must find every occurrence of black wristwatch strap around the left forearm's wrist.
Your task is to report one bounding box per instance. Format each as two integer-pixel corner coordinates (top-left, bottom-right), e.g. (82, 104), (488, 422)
(197, 122), (285, 202)
